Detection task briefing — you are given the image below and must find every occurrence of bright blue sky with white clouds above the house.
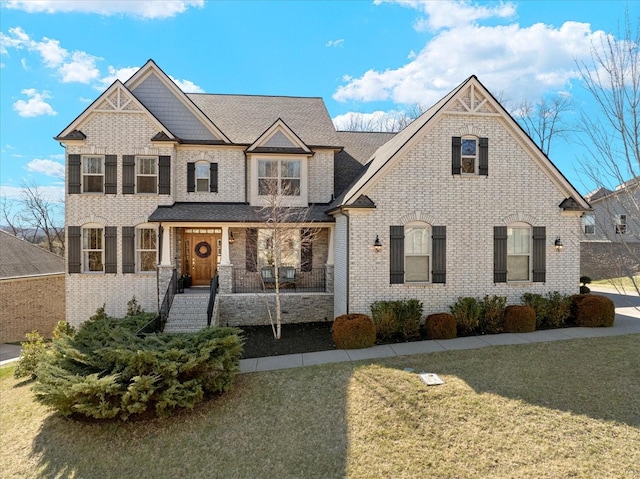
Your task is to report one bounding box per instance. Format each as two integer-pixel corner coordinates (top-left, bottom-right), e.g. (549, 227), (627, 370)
(0, 0), (640, 209)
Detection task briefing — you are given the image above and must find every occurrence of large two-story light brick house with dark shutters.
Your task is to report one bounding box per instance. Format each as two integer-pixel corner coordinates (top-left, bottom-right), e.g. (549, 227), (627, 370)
(56, 60), (589, 325)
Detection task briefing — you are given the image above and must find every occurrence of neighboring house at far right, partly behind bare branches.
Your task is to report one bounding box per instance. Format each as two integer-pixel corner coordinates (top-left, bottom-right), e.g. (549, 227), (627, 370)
(580, 177), (640, 279)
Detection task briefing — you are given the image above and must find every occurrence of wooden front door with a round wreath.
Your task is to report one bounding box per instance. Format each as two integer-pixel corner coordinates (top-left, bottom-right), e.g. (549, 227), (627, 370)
(182, 228), (222, 286)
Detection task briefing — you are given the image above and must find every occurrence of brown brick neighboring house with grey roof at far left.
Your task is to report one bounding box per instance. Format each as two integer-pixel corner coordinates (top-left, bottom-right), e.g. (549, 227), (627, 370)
(0, 231), (65, 343)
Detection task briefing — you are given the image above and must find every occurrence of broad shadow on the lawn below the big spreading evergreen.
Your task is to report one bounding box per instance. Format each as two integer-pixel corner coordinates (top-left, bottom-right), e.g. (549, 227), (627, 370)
(32, 368), (351, 479)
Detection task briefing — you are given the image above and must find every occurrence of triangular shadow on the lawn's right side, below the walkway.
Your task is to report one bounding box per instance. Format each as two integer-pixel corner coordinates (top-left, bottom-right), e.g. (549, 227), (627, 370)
(385, 334), (640, 427)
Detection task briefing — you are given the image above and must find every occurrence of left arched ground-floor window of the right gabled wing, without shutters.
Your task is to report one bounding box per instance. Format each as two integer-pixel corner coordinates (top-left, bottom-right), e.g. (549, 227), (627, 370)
(404, 223), (431, 283)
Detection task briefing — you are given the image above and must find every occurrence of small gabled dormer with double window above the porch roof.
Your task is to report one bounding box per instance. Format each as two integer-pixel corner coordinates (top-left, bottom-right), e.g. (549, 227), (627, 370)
(245, 118), (313, 206)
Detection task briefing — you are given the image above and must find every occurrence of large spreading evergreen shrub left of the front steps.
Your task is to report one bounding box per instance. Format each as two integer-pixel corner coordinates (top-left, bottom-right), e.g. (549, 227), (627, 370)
(34, 314), (242, 420)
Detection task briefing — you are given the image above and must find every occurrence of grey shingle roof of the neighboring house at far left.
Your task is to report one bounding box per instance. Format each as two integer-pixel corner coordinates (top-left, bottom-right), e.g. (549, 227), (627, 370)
(0, 231), (64, 278)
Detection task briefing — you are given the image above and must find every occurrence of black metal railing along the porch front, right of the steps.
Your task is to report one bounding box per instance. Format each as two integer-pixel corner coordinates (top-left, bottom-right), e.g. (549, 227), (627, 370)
(233, 268), (327, 293)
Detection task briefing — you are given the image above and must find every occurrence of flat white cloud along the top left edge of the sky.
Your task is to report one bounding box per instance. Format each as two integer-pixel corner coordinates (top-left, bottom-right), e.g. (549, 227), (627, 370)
(5, 0), (204, 19)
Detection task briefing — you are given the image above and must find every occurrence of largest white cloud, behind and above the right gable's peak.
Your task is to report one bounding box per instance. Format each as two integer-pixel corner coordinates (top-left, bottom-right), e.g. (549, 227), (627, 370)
(333, 1), (604, 105)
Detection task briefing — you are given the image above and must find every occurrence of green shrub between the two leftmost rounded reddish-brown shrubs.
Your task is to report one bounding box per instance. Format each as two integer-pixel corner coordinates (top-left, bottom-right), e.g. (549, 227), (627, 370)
(371, 299), (423, 340)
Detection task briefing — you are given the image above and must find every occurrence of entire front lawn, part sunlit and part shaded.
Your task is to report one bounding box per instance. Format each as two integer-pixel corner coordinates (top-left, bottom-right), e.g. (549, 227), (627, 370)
(0, 335), (640, 479)
